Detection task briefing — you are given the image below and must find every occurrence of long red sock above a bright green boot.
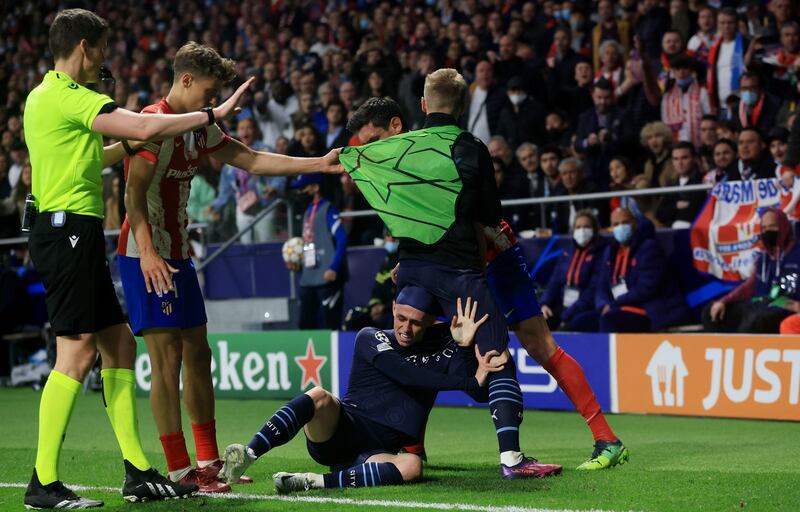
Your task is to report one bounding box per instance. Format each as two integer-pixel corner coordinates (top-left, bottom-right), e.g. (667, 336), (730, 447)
(544, 347), (617, 441)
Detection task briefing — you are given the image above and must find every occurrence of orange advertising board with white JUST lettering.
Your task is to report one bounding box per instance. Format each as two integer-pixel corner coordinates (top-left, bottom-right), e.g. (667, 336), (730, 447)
(611, 334), (800, 421)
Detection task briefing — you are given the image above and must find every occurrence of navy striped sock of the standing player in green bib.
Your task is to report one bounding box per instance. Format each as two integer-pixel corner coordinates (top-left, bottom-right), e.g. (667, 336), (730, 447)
(489, 359), (522, 453)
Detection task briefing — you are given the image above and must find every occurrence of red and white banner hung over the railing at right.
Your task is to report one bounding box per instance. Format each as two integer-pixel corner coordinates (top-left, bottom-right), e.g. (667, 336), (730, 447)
(691, 178), (800, 281)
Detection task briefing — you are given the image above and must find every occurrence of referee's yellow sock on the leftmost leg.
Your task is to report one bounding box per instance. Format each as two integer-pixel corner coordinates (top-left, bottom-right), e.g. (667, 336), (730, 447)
(35, 370), (81, 485)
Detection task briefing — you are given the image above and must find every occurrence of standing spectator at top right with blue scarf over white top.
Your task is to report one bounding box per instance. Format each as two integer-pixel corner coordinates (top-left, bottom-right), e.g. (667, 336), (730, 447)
(708, 7), (747, 113)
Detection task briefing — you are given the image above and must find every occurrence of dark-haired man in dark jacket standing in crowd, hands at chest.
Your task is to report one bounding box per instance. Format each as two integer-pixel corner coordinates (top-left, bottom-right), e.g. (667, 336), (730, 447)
(574, 80), (630, 188)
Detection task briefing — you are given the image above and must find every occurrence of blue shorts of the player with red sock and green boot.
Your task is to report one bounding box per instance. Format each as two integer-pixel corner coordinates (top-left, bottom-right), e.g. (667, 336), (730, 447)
(486, 244), (542, 325)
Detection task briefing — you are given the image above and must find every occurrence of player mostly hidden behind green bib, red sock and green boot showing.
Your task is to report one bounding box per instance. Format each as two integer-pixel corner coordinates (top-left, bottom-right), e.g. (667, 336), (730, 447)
(347, 97), (629, 470)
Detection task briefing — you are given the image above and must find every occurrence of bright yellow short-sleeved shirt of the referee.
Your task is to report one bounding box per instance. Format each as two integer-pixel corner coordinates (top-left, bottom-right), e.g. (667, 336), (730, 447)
(24, 71), (116, 219)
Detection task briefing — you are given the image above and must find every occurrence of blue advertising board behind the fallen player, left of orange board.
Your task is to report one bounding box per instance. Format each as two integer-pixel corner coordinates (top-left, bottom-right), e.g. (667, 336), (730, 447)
(338, 332), (611, 410)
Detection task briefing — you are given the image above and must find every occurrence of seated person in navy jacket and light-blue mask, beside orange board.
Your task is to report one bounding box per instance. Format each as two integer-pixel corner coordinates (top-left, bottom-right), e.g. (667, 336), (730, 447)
(582, 208), (686, 332)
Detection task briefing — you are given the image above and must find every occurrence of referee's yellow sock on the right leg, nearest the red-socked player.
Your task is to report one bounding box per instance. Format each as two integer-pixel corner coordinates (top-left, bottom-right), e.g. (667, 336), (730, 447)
(100, 368), (150, 471)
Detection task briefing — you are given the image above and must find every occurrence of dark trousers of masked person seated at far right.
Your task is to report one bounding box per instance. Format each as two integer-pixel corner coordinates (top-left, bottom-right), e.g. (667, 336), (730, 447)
(703, 301), (792, 334)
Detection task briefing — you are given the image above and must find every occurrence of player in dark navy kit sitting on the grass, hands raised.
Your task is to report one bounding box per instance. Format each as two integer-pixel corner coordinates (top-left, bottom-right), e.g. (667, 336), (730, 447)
(222, 286), (561, 492)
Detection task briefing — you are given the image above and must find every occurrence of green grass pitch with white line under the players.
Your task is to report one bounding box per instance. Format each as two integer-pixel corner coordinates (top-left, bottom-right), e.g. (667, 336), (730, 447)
(0, 389), (800, 512)
